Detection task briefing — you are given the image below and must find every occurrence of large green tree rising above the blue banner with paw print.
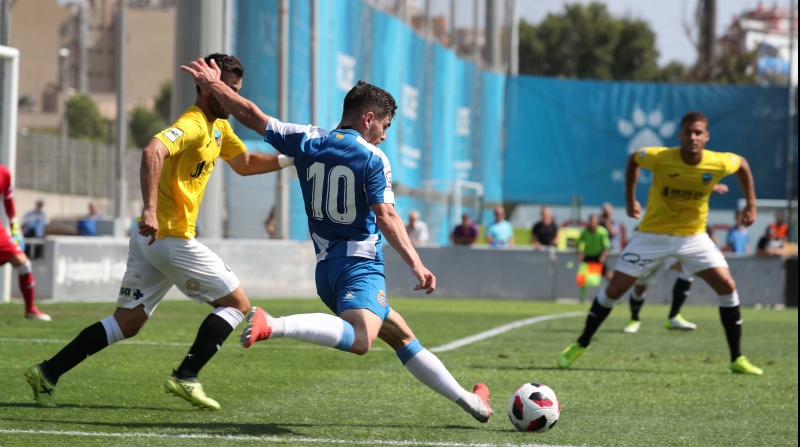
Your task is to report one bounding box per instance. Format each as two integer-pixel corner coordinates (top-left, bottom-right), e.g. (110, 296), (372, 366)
(519, 2), (658, 80)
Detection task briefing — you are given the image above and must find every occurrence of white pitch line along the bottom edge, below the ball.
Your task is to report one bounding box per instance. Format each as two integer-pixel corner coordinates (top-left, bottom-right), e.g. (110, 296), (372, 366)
(0, 429), (571, 447)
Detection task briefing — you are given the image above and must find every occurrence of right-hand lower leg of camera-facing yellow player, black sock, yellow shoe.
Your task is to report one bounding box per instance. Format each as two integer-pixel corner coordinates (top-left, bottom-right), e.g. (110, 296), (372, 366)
(697, 267), (763, 375)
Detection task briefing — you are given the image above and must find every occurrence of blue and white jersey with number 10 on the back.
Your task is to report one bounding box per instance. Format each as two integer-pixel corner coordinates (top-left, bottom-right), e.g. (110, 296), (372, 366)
(264, 118), (394, 261)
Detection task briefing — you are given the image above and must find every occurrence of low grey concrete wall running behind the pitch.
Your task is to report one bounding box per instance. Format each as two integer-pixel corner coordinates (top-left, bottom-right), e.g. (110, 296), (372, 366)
(12, 236), (796, 305)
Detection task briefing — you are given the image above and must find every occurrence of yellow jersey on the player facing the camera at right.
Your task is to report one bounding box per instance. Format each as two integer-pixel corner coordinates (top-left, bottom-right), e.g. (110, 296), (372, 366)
(635, 147), (742, 236)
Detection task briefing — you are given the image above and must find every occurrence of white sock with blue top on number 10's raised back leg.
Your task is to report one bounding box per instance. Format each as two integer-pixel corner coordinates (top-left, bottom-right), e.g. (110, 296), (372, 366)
(269, 313), (354, 351)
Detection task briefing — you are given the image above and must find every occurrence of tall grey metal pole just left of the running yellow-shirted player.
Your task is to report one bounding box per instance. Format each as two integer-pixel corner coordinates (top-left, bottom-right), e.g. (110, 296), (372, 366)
(114, 0), (128, 237)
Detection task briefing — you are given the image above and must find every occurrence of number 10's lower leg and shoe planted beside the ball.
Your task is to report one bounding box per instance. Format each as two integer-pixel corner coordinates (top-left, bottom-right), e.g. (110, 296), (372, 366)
(378, 310), (492, 422)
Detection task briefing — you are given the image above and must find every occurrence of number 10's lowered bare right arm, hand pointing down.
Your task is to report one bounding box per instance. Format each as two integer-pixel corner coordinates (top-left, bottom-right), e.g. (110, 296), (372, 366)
(372, 203), (436, 294)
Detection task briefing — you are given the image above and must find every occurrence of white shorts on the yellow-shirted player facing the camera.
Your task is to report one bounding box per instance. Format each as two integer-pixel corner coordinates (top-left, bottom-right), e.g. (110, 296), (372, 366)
(615, 232), (728, 278)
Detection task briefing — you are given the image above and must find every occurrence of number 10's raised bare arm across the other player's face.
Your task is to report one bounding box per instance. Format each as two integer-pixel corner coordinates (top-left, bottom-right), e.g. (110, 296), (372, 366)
(181, 58), (271, 135)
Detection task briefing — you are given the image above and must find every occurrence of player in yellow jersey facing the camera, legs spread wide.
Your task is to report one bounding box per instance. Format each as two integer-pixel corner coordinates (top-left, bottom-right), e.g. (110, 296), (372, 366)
(557, 112), (763, 375)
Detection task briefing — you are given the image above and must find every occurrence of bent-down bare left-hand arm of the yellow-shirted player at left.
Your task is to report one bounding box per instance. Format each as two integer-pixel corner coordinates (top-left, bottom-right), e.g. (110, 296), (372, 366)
(139, 138), (169, 245)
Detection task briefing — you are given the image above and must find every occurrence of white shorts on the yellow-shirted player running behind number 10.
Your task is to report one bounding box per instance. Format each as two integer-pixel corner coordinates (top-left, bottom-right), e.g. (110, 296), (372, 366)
(117, 233), (239, 317)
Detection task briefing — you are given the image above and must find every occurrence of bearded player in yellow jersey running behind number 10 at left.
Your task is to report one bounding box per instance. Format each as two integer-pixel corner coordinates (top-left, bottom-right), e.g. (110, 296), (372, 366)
(25, 54), (291, 410)
